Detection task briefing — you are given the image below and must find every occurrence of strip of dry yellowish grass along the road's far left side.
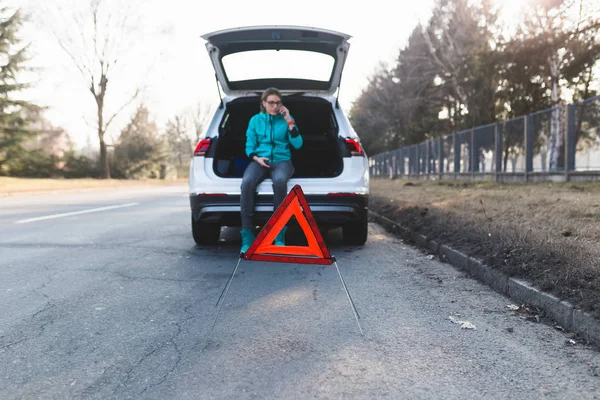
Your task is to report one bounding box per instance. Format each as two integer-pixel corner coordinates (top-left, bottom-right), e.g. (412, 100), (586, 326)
(0, 177), (187, 197)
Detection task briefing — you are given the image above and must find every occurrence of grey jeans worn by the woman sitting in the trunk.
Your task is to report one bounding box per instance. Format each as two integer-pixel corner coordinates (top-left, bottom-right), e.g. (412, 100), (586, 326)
(240, 161), (294, 229)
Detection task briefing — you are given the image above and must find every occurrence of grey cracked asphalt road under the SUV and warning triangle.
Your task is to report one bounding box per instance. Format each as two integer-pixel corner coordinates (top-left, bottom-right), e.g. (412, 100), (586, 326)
(0, 187), (600, 399)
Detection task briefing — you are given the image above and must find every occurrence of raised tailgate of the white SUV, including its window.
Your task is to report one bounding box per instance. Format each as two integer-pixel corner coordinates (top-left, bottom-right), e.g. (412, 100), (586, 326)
(202, 25), (351, 96)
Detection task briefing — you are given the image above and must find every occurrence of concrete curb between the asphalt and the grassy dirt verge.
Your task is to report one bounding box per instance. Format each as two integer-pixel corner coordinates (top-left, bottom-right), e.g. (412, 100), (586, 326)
(369, 210), (600, 346)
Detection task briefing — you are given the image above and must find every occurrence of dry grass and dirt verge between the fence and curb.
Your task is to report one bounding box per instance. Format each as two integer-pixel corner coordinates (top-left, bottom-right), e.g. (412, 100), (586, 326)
(369, 179), (600, 318)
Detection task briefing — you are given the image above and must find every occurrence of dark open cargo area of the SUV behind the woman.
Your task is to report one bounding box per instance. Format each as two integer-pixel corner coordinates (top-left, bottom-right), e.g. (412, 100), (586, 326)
(213, 95), (347, 178)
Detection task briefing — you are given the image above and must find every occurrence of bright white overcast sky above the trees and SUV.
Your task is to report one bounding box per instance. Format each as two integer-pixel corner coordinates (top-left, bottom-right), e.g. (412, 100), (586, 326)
(5, 0), (519, 147)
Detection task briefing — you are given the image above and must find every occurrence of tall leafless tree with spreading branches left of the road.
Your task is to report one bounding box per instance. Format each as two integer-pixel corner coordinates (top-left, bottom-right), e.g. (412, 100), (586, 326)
(40, 0), (148, 179)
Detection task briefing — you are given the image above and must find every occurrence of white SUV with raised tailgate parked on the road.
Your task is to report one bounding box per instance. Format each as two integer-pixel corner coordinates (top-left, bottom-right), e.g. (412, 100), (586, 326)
(189, 26), (369, 245)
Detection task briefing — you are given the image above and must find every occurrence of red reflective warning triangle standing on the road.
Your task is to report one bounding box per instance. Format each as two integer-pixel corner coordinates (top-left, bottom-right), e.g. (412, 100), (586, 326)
(244, 185), (333, 265)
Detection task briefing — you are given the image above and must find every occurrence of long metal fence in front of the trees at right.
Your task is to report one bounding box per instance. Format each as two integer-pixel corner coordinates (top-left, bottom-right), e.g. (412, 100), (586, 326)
(369, 96), (600, 181)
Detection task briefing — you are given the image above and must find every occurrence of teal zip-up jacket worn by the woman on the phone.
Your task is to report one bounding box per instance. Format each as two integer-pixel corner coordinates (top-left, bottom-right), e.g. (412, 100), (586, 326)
(246, 112), (303, 163)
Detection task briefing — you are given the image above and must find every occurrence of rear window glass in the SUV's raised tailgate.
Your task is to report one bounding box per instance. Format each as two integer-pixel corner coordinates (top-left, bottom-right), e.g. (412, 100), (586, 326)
(221, 50), (335, 82)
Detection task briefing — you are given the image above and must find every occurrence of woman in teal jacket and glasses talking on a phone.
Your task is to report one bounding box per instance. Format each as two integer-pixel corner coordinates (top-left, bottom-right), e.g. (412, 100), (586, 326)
(240, 88), (302, 253)
